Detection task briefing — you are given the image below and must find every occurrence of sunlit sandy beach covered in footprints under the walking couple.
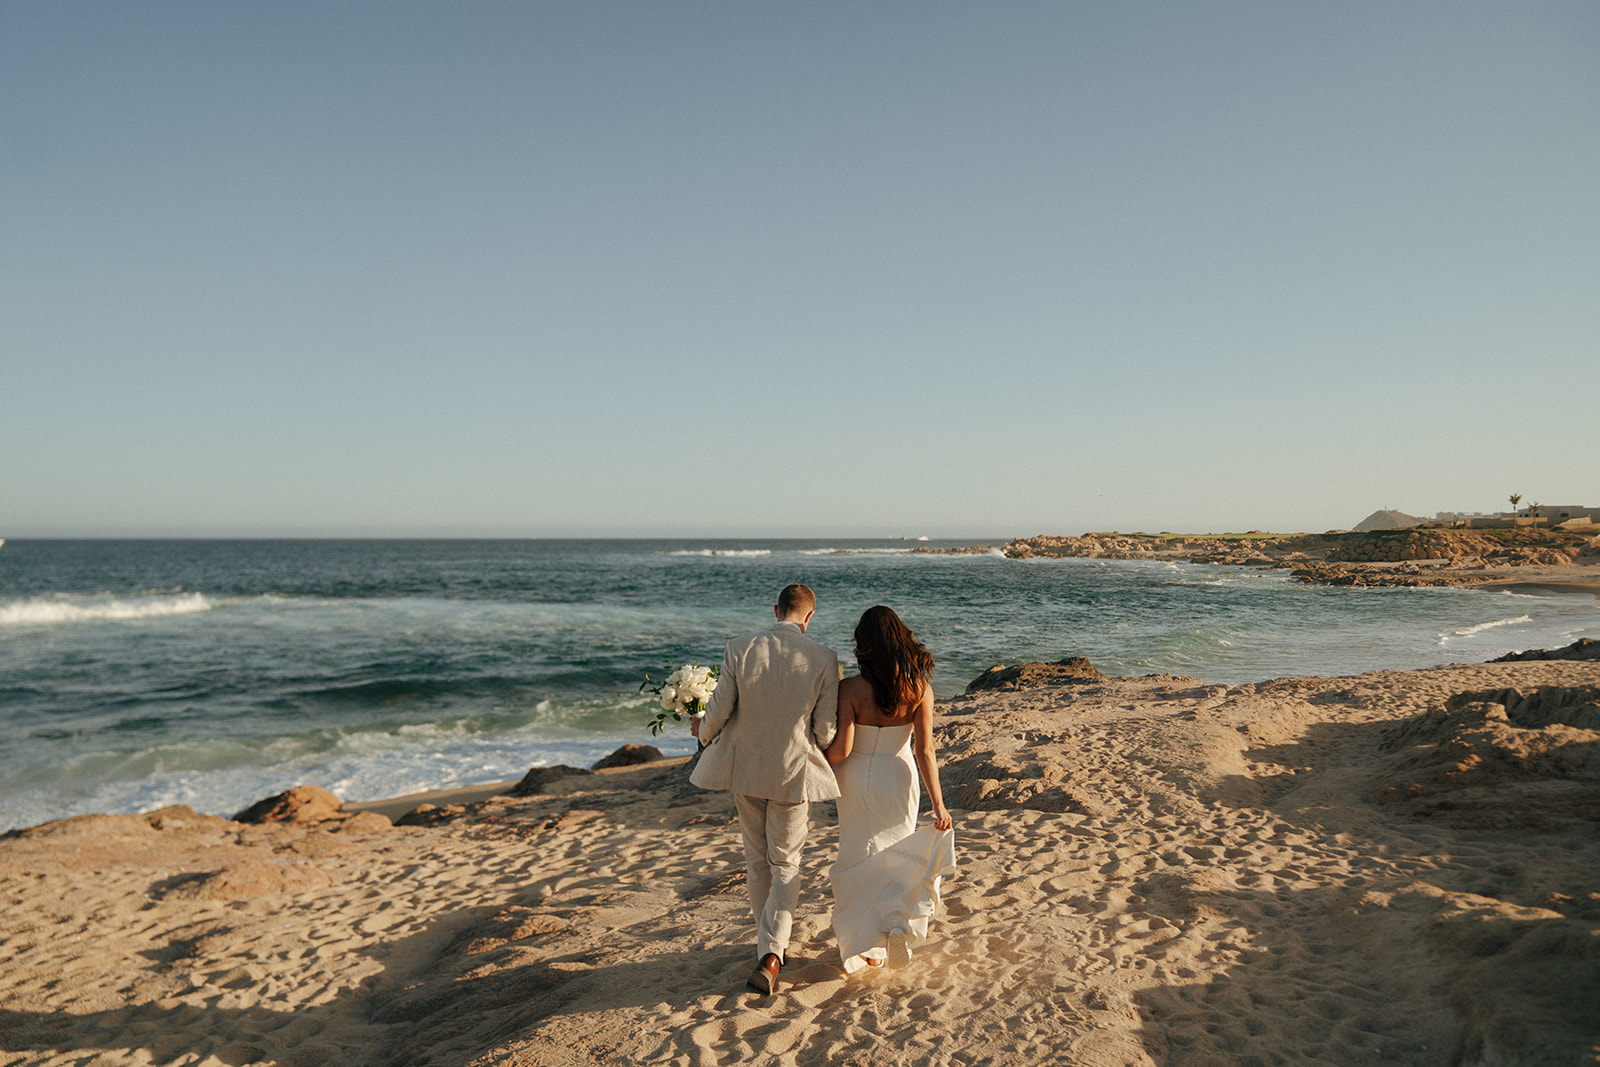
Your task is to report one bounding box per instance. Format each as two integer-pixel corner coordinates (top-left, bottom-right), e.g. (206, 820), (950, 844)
(0, 643), (1600, 1067)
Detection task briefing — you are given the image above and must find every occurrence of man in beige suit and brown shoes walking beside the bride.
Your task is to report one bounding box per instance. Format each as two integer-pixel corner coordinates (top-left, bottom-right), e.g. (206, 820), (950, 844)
(690, 585), (838, 995)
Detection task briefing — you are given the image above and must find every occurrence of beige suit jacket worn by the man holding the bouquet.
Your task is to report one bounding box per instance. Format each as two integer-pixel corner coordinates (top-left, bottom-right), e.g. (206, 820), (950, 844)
(690, 622), (838, 803)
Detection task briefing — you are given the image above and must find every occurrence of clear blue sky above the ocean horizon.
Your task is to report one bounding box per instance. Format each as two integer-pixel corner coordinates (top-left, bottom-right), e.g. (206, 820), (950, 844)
(0, 0), (1600, 537)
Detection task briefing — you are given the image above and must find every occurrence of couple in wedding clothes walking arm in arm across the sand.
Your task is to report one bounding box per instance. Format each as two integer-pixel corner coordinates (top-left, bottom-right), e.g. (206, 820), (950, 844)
(690, 585), (955, 993)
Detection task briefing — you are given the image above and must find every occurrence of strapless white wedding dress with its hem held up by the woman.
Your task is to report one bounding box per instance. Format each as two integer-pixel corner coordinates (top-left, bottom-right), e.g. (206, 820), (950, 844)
(832, 723), (955, 974)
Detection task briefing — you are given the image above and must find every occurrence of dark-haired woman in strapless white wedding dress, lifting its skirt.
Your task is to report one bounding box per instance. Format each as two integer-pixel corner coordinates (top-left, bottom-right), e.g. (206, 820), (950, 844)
(827, 605), (955, 973)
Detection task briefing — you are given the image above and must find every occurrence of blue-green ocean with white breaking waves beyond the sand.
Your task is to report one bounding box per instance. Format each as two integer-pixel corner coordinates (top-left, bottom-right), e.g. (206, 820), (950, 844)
(0, 537), (1600, 830)
